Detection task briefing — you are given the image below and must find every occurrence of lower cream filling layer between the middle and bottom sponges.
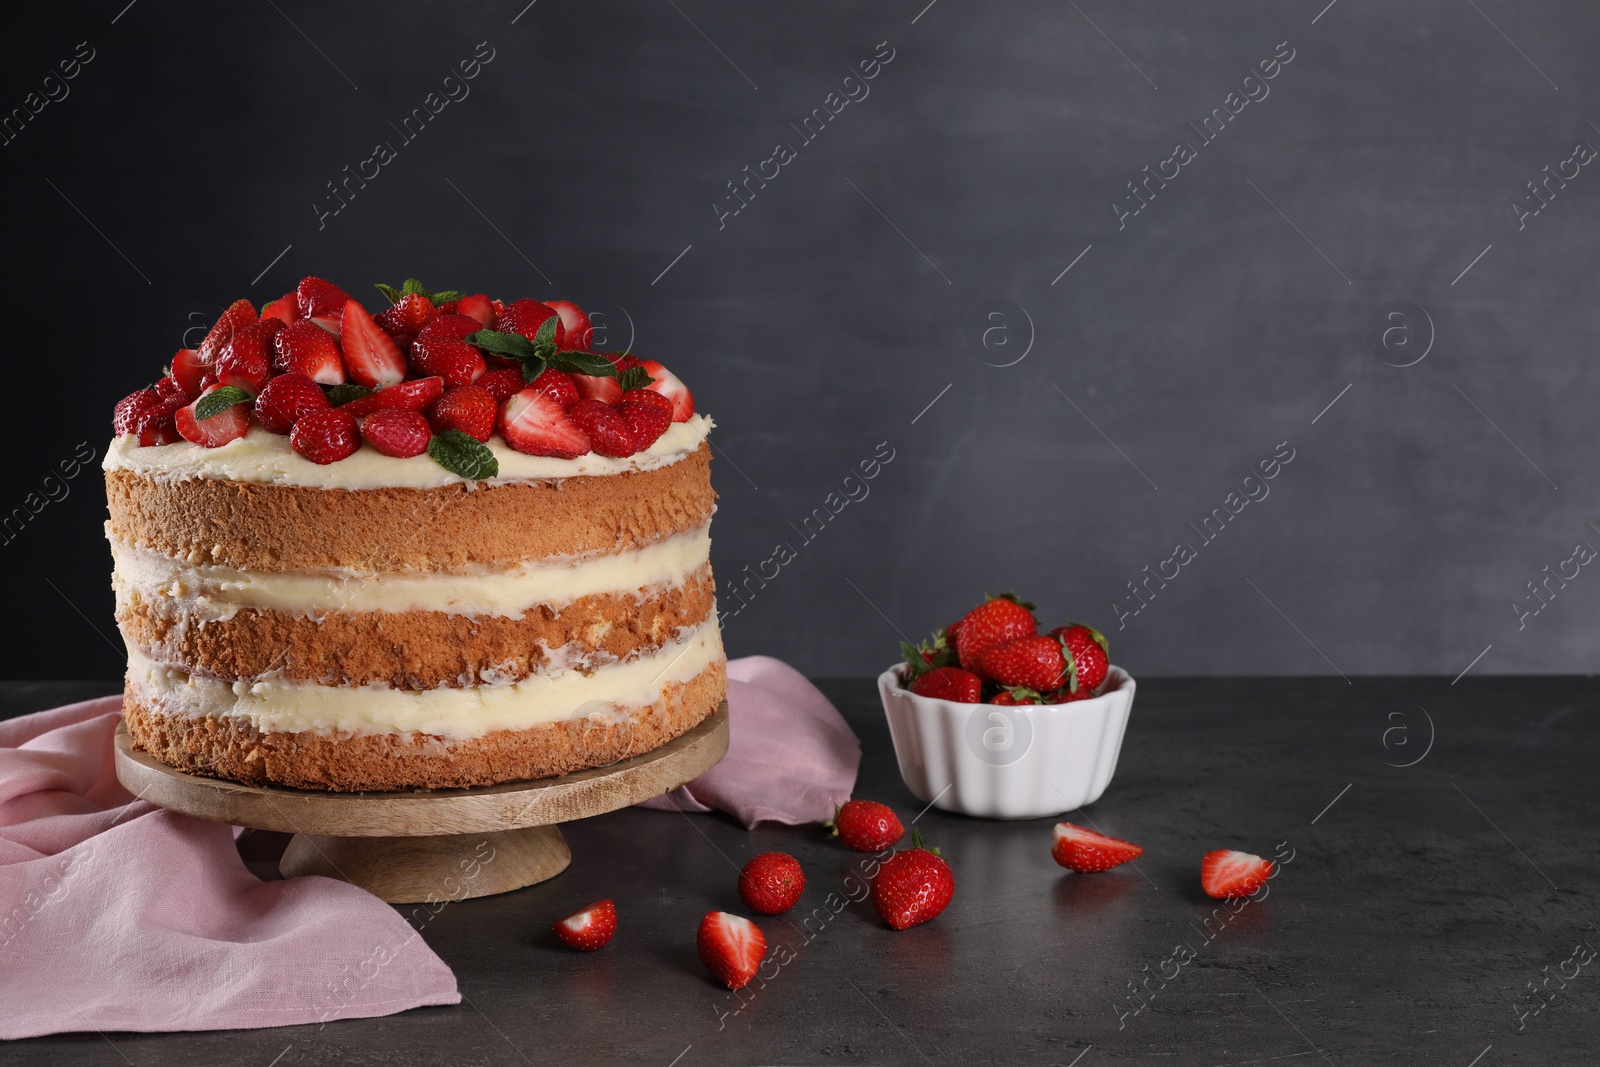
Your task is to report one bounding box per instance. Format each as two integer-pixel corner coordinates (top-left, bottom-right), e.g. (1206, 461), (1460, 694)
(128, 614), (723, 741)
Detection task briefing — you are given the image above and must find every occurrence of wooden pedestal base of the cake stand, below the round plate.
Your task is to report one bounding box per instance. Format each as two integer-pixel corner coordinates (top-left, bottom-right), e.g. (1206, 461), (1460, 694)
(278, 825), (573, 904)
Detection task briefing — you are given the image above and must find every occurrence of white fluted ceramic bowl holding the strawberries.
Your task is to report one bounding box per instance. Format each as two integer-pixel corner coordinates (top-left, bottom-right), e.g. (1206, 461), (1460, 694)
(878, 664), (1134, 819)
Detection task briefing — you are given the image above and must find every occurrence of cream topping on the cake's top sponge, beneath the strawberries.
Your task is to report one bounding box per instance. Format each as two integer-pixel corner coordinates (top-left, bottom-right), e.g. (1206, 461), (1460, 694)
(101, 414), (712, 490)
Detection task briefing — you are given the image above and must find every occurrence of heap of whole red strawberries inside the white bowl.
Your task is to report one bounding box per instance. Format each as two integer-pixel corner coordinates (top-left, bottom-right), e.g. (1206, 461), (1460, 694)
(901, 593), (1110, 704)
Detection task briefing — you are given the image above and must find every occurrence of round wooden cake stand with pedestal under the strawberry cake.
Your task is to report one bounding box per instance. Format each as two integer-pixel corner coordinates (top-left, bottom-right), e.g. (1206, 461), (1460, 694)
(117, 701), (728, 904)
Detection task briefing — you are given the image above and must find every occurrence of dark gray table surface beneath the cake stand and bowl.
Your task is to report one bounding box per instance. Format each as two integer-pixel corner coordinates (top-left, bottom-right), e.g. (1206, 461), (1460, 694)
(0, 677), (1600, 1067)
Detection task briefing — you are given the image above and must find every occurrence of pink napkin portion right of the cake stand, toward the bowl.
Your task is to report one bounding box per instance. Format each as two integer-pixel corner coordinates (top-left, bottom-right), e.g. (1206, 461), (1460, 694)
(638, 656), (861, 827)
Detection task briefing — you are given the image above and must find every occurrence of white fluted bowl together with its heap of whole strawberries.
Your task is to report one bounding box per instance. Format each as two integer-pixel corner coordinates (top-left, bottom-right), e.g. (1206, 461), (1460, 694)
(878, 593), (1134, 819)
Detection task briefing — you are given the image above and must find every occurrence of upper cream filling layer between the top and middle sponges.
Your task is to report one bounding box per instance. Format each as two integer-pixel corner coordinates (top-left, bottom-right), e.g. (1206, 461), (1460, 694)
(107, 523), (710, 622)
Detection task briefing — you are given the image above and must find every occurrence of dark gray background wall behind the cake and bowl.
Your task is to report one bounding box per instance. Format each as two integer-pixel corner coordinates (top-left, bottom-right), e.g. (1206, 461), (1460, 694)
(0, 0), (1600, 677)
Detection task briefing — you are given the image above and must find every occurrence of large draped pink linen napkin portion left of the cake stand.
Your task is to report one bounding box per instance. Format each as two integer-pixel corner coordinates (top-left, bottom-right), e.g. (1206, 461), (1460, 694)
(0, 696), (461, 1038)
